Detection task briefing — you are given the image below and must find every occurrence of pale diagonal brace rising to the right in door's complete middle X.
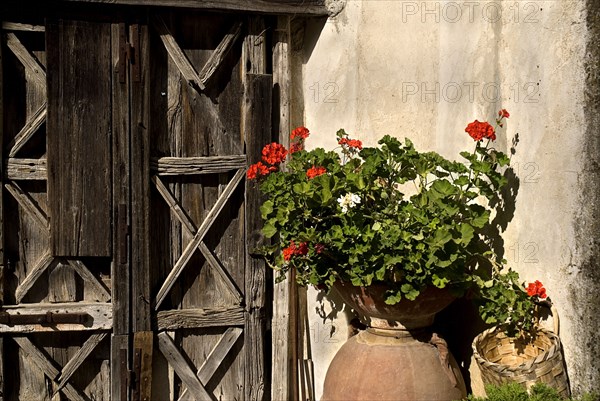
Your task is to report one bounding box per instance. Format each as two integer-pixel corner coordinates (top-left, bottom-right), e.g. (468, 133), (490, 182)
(155, 169), (246, 310)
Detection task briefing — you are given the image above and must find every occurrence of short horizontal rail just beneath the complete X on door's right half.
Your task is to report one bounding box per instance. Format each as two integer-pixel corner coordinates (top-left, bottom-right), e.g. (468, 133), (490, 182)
(156, 306), (244, 331)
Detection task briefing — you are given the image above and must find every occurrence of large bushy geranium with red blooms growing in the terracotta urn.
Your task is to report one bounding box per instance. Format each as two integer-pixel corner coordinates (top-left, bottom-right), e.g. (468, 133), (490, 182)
(247, 110), (509, 304)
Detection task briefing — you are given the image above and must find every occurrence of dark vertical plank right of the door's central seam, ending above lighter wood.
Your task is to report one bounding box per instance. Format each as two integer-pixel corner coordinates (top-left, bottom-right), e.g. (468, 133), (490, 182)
(130, 25), (152, 332)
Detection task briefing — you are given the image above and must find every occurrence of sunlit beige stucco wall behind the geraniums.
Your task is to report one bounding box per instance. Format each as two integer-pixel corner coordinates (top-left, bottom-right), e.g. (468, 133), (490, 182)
(302, 0), (600, 398)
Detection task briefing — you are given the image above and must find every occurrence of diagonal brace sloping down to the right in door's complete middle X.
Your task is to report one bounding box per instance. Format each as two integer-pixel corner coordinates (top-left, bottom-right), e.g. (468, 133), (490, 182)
(152, 176), (244, 302)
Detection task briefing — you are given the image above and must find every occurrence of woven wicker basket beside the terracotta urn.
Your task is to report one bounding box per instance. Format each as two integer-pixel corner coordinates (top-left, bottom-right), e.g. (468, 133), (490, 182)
(473, 327), (570, 397)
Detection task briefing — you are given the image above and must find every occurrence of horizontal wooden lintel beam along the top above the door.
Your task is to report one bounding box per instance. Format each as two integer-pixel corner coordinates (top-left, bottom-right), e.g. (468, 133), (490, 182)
(46, 0), (328, 16)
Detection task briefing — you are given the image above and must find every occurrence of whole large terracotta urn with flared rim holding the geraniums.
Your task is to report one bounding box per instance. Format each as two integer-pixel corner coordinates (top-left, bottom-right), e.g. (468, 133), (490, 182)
(321, 282), (466, 401)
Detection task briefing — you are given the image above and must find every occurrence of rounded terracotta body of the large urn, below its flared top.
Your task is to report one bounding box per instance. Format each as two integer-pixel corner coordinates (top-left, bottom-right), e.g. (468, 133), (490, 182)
(321, 329), (466, 401)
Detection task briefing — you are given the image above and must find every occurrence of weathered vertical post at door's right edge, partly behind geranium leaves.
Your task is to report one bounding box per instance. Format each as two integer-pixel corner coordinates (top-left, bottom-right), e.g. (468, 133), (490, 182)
(242, 16), (273, 401)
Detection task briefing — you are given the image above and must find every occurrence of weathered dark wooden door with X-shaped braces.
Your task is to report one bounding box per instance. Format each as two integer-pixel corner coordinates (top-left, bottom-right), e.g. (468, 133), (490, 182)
(0, 9), (272, 401)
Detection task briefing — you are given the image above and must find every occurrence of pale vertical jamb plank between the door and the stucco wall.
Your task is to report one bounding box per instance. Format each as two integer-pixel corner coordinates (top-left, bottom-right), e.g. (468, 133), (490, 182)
(271, 16), (295, 400)
